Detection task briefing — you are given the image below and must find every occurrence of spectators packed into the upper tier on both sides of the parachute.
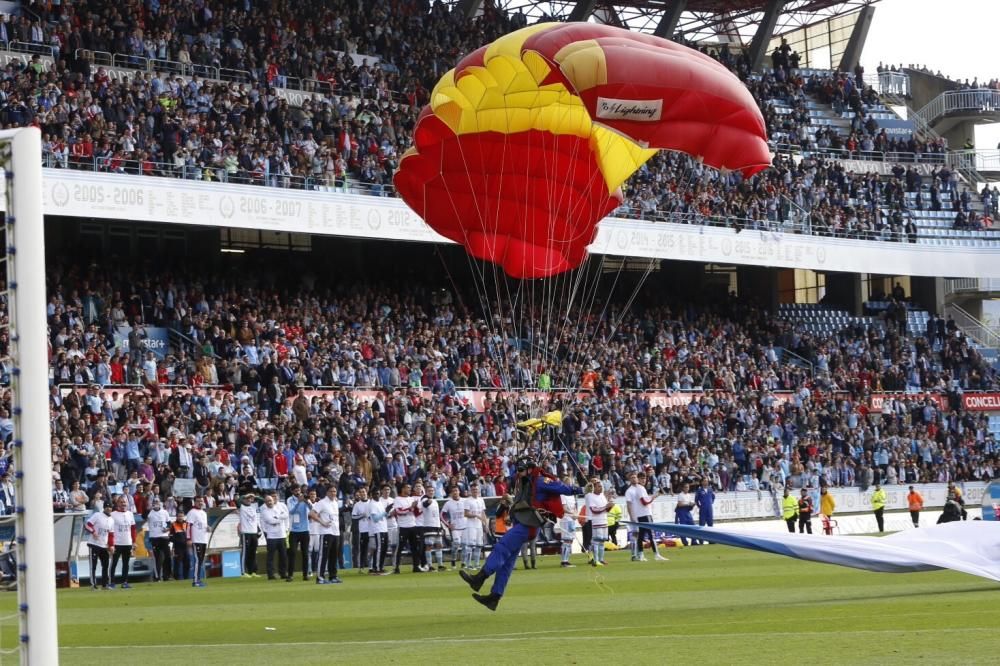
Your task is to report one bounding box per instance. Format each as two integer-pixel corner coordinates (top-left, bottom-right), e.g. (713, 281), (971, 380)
(0, 0), (980, 240)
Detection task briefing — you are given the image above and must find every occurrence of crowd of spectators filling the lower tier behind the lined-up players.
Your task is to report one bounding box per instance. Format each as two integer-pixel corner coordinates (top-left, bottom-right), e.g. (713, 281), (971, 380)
(0, 255), (997, 520)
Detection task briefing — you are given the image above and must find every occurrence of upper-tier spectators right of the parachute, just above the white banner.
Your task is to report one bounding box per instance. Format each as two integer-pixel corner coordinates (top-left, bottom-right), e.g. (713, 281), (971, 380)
(618, 153), (980, 243)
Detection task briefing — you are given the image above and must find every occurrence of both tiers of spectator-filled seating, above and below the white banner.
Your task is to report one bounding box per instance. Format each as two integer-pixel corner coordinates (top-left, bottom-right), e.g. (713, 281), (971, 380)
(0, 0), (1000, 524)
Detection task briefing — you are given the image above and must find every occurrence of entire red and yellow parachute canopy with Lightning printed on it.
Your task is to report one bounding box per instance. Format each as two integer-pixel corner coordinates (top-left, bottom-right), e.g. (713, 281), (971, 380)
(394, 23), (770, 278)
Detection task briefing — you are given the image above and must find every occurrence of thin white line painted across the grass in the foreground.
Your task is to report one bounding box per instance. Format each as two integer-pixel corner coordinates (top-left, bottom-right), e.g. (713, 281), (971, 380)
(59, 627), (995, 650)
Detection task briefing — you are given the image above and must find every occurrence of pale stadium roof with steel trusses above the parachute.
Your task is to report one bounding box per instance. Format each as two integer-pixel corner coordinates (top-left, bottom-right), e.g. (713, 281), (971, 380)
(462, 0), (878, 44)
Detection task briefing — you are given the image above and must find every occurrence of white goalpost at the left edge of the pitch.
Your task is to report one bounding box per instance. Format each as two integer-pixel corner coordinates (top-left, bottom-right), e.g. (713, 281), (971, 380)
(0, 127), (59, 666)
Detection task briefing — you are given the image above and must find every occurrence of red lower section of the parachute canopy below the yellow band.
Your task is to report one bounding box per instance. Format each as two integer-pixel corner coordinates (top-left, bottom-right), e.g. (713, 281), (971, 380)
(395, 115), (621, 278)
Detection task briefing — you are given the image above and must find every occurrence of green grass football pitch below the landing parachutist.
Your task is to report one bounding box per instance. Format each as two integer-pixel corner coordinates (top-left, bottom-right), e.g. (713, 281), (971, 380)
(0, 546), (1000, 665)
